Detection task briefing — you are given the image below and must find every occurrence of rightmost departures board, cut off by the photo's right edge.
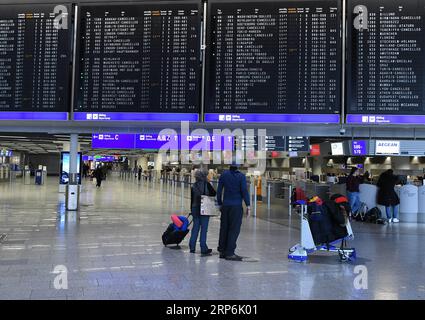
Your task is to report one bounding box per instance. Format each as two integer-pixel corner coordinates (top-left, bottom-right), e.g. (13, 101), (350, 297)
(346, 0), (425, 124)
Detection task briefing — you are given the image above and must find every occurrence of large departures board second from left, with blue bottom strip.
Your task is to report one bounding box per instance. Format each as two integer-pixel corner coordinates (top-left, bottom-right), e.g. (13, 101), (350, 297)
(74, 1), (201, 121)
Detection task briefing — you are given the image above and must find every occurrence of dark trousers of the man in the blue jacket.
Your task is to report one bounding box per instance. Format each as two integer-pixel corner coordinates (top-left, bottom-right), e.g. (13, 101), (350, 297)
(218, 205), (243, 257)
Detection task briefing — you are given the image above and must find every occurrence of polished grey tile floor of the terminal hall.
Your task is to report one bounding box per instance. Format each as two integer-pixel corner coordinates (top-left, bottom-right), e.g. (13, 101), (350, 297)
(0, 172), (425, 300)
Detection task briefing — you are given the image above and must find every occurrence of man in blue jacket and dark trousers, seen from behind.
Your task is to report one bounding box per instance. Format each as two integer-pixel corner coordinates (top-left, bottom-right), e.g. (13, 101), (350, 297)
(217, 162), (250, 261)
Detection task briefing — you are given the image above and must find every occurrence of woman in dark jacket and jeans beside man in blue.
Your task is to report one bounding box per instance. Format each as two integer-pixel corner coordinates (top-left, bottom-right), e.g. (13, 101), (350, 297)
(189, 170), (216, 256)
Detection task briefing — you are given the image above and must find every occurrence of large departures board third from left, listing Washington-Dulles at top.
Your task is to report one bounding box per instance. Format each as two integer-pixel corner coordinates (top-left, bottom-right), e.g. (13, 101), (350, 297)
(204, 0), (341, 123)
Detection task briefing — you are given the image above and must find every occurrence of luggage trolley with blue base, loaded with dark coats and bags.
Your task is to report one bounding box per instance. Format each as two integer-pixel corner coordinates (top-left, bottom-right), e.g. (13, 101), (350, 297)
(288, 200), (356, 262)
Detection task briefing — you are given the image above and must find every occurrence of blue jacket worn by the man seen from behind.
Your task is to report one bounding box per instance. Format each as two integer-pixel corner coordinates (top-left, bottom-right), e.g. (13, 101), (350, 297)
(217, 170), (251, 206)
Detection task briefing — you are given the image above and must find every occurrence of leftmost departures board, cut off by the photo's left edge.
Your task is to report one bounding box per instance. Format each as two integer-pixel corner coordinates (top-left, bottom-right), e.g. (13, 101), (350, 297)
(0, 4), (72, 120)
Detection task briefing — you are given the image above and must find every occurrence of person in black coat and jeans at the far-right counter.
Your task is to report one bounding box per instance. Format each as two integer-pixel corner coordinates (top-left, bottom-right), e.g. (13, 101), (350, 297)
(376, 169), (400, 223)
